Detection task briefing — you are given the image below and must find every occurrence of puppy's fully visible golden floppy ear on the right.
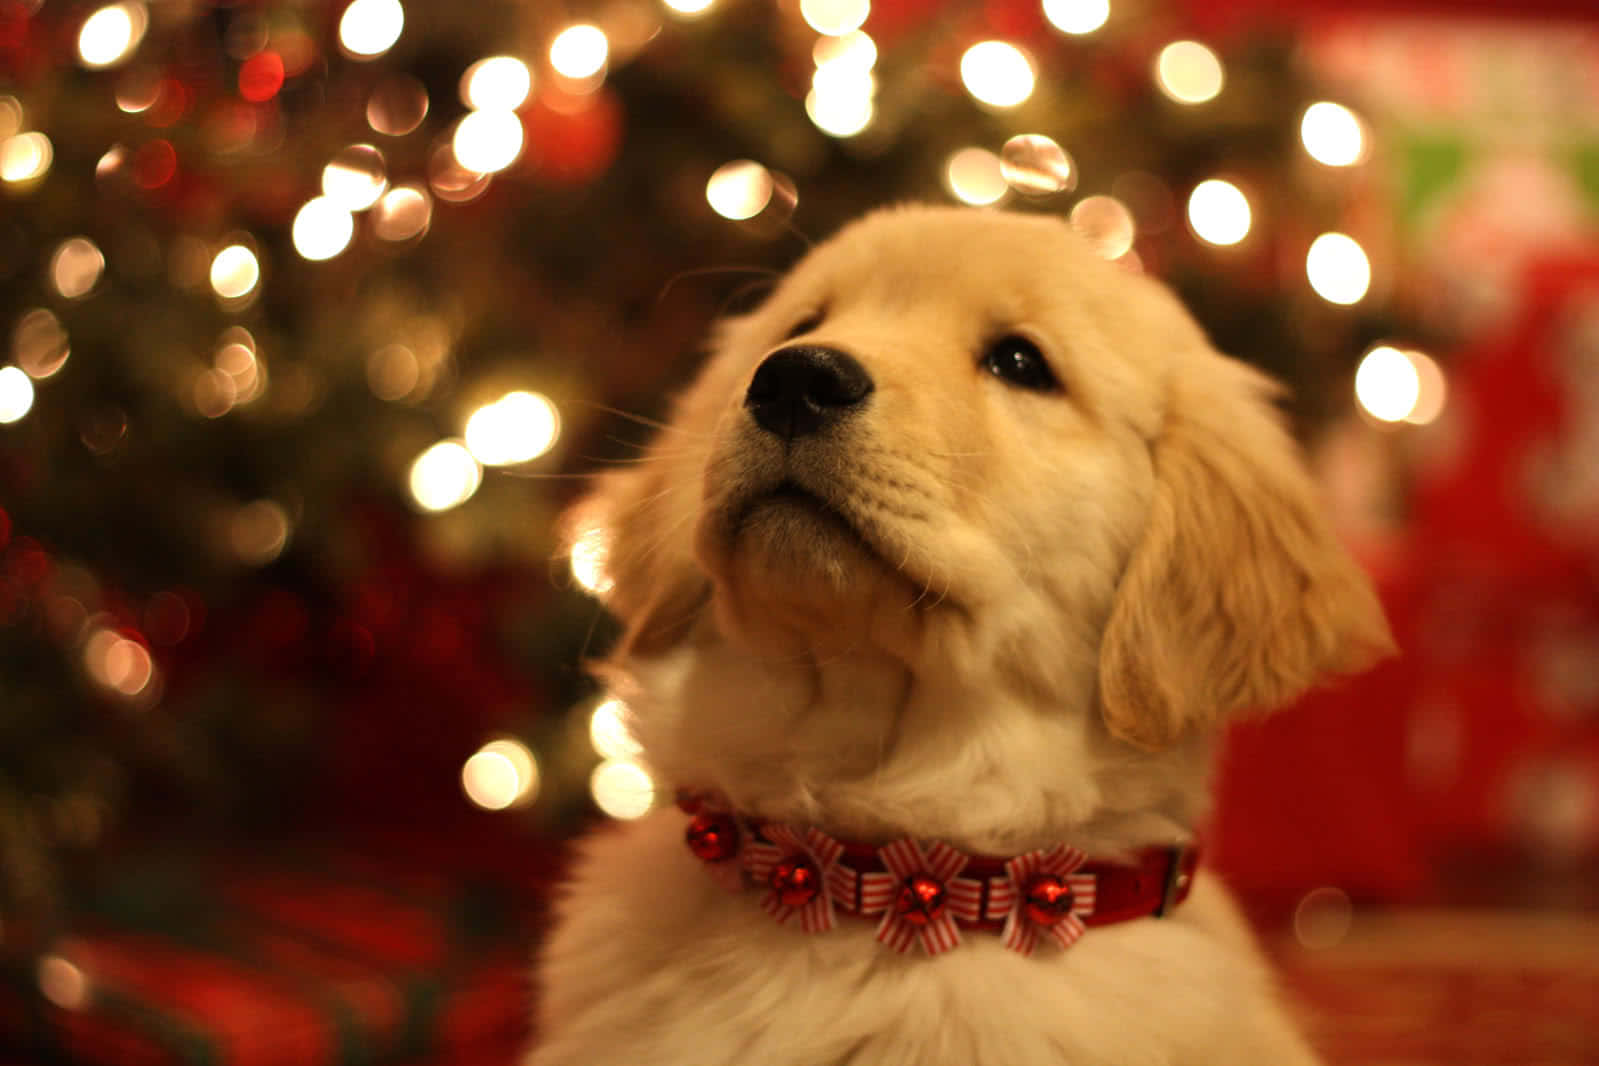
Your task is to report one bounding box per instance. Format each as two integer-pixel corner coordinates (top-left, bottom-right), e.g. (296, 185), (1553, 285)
(1100, 348), (1393, 748)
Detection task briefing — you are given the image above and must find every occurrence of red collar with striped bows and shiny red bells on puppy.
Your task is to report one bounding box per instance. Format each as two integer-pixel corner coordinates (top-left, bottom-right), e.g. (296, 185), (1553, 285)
(678, 793), (1199, 954)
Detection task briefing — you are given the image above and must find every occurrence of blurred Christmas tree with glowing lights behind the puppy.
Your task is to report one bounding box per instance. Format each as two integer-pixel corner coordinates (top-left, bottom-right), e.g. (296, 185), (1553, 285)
(0, 0), (1426, 920)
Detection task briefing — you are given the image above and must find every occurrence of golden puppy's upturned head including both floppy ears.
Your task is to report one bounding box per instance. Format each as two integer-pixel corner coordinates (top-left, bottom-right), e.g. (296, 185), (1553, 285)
(582, 209), (1388, 746)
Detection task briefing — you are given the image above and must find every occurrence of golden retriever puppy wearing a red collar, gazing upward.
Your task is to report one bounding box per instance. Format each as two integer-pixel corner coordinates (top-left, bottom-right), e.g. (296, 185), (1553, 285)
(526, 208), (1390, 1066)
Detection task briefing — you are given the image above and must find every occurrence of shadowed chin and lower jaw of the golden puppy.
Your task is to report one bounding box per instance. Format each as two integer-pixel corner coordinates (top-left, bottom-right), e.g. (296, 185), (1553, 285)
(696, 489), (924, 657)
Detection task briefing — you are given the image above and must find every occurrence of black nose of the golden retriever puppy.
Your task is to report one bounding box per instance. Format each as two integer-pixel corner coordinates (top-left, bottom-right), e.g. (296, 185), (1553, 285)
(744, 344), (873, 441)
